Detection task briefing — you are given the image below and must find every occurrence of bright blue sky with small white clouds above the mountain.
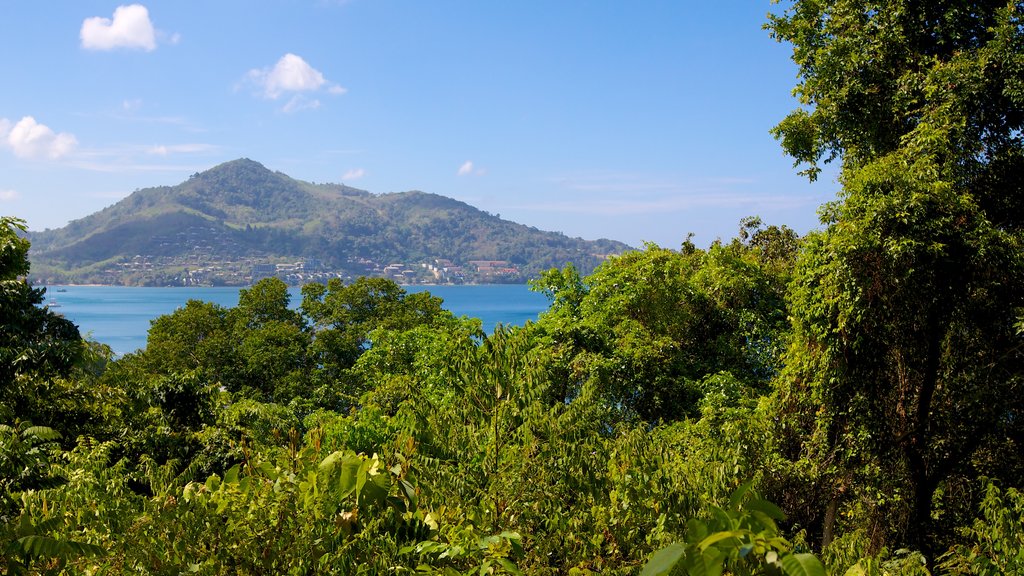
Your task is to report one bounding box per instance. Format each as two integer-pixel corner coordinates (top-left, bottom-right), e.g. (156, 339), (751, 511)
(0, 0), (838, 248)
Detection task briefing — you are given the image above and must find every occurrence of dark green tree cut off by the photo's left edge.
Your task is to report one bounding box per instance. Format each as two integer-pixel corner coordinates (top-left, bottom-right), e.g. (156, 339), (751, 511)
(0, 216), (102, 574)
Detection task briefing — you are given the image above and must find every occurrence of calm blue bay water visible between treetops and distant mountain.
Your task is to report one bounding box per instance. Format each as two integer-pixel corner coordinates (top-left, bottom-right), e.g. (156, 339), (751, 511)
(46, 284), (548, 355)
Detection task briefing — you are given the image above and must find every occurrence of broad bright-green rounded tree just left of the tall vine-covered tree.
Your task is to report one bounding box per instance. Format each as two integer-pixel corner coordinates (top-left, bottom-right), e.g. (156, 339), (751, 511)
(534, 234), (796, 422)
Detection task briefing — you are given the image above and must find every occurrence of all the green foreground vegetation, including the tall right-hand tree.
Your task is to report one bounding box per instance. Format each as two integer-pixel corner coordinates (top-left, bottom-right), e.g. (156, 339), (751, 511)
(0, 0), (1024, 576)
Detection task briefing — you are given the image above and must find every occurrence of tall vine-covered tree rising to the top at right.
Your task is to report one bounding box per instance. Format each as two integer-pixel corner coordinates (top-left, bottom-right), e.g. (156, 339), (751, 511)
(768, 0), (1024, 551)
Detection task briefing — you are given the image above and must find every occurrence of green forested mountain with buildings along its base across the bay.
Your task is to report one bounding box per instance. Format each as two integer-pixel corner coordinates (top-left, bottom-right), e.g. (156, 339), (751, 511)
(30, 159), (629, 285)
